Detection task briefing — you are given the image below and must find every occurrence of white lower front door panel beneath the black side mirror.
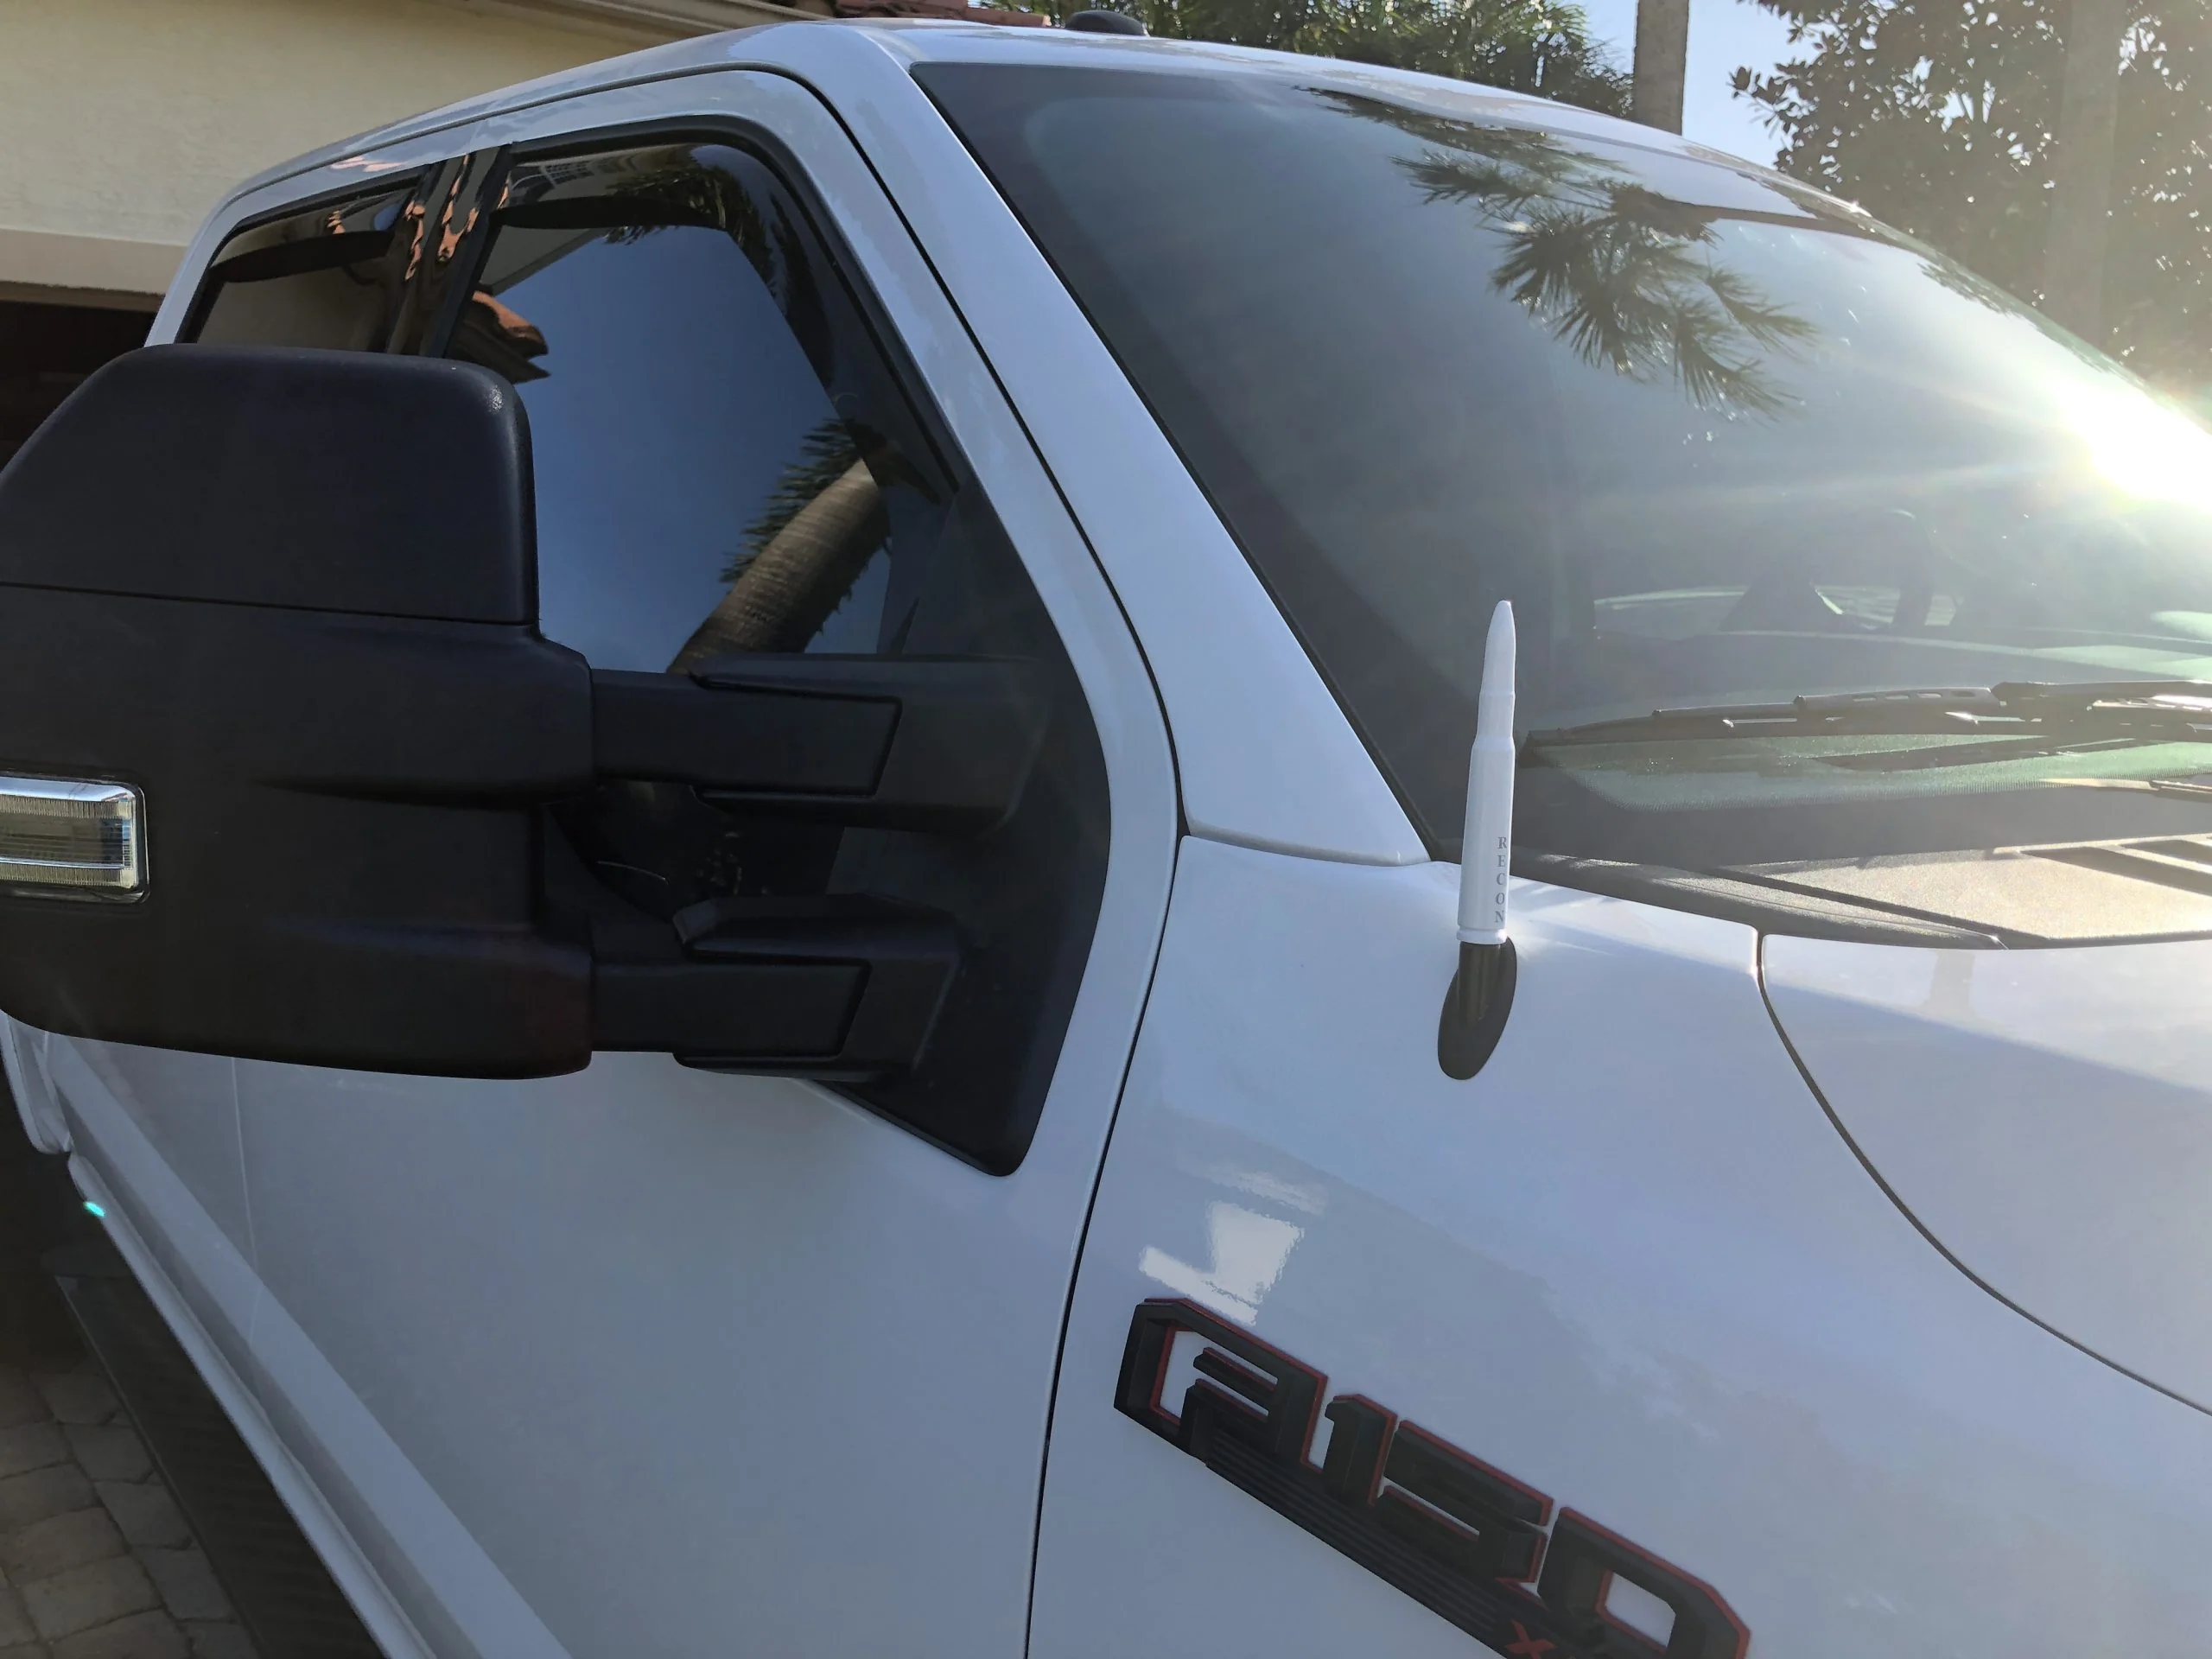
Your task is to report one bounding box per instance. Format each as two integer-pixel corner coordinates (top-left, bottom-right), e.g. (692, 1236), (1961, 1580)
(244, 1055), (1068, 1655)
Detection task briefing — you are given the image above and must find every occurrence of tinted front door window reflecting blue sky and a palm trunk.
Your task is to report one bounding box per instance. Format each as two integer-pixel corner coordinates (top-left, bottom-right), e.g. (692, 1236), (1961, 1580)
(451, 146), (906, 671)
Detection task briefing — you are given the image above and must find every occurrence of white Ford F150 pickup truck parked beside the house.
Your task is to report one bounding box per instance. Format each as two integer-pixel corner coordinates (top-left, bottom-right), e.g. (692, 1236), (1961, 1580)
(0, 22), (2212, 1659)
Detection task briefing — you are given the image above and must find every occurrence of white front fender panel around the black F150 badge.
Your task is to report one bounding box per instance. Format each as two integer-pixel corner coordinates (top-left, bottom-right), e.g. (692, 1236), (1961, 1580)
(1033, 841), (2212, 1659)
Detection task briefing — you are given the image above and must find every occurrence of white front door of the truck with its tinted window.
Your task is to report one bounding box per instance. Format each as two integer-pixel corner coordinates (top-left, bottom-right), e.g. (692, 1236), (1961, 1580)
(48, 73), (1174, 1659)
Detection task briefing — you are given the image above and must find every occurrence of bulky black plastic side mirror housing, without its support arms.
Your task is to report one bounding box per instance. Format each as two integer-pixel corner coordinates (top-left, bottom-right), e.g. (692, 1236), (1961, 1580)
(0, 345), (591, 1075)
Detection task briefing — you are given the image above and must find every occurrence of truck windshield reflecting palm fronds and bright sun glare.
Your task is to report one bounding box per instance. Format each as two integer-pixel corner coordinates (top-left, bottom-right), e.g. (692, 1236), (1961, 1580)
(916, 64), (2212, 865)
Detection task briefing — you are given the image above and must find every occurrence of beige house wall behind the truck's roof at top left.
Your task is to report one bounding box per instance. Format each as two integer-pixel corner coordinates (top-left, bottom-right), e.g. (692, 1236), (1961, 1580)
(0, 0), (827, 303)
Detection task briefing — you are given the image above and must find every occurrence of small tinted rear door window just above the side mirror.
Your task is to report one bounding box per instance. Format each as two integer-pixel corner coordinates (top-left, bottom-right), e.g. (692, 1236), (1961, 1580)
(179, 179), (423, 352)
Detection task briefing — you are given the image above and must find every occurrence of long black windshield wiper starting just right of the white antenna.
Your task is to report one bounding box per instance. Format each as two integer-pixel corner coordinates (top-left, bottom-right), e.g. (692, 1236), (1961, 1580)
(1524, 679), (2212, 747)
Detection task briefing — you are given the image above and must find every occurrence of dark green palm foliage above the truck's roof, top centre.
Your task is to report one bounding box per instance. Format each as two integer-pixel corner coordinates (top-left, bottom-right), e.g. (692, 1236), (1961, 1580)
(1028, 0), (1628, 115)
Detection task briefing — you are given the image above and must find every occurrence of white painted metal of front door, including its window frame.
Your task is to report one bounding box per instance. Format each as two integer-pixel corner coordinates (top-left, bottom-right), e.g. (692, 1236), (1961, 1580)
(219, 73), (1174, 1659)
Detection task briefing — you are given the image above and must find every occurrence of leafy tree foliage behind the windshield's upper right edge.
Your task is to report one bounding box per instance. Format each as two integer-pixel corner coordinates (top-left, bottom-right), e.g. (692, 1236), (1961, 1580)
(1734, 0), (2212, 390)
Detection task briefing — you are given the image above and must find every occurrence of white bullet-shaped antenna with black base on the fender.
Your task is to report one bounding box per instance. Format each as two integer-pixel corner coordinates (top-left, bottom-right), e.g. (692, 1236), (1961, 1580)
(1435, 600), (1516, 1077)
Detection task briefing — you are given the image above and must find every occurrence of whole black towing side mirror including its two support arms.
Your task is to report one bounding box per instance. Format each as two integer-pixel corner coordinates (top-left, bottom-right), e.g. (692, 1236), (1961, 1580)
(0, 347), (1044, 1079)
